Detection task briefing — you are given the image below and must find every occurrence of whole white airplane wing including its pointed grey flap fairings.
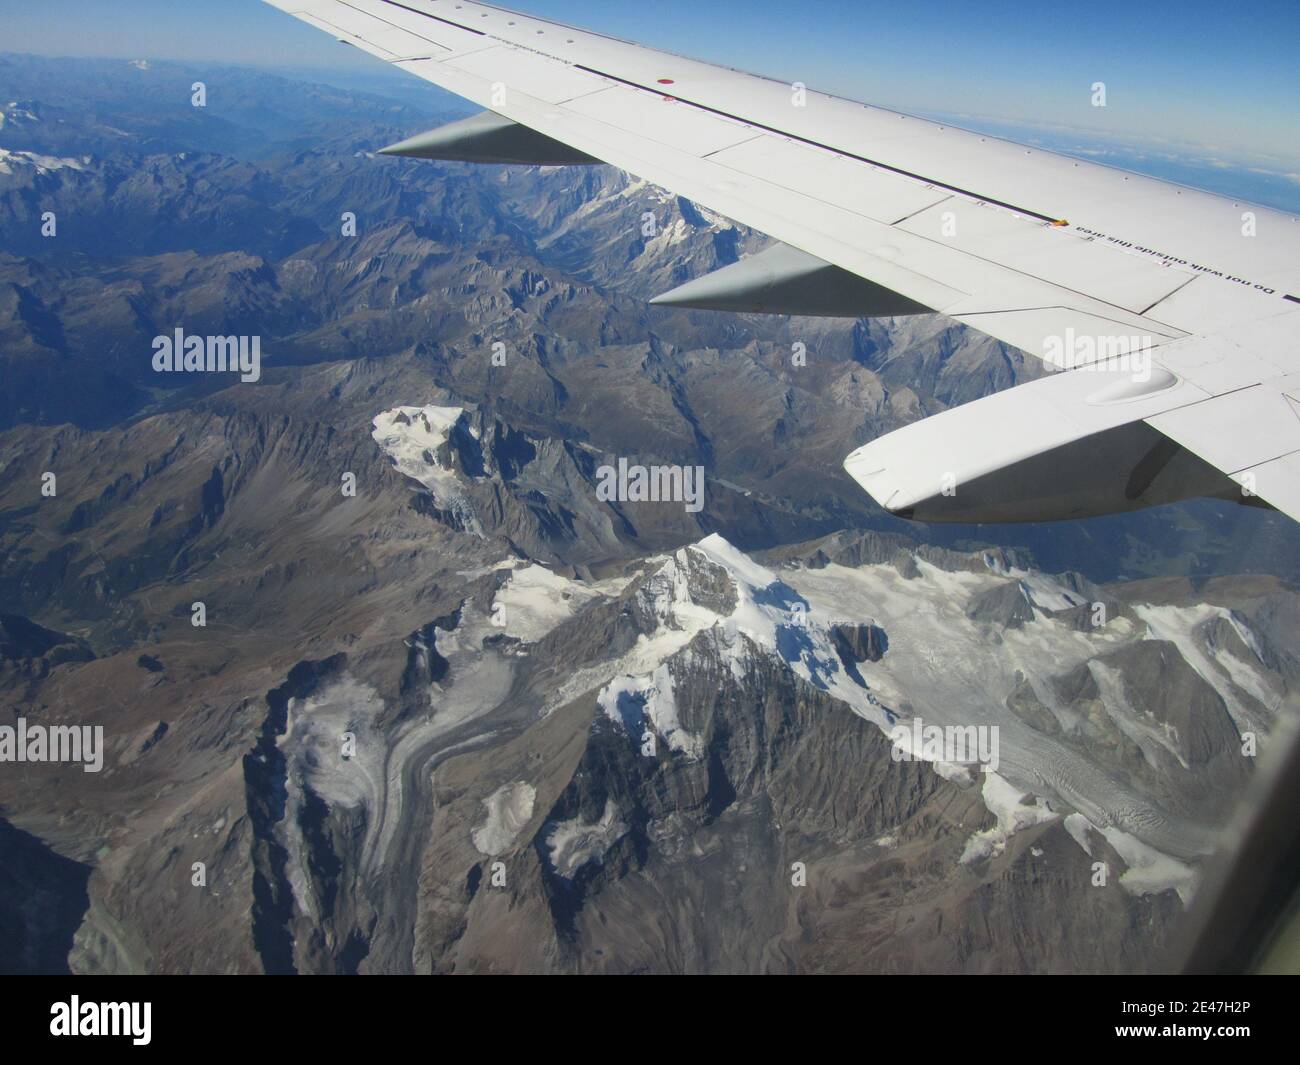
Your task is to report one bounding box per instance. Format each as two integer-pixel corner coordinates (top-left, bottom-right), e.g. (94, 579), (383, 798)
(268, 0), (1300, 521)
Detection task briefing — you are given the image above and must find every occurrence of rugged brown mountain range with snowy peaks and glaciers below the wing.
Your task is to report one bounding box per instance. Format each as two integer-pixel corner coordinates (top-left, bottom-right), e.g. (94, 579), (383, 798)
(0, 56), (1300, 973)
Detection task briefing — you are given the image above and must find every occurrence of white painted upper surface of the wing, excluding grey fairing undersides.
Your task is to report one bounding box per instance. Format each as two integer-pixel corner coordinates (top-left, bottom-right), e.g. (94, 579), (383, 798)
(268, 0), (1300, 518)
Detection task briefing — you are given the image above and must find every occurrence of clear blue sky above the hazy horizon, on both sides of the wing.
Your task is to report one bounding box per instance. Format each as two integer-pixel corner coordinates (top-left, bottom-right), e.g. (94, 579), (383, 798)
(10, 0), (1300, 189)
